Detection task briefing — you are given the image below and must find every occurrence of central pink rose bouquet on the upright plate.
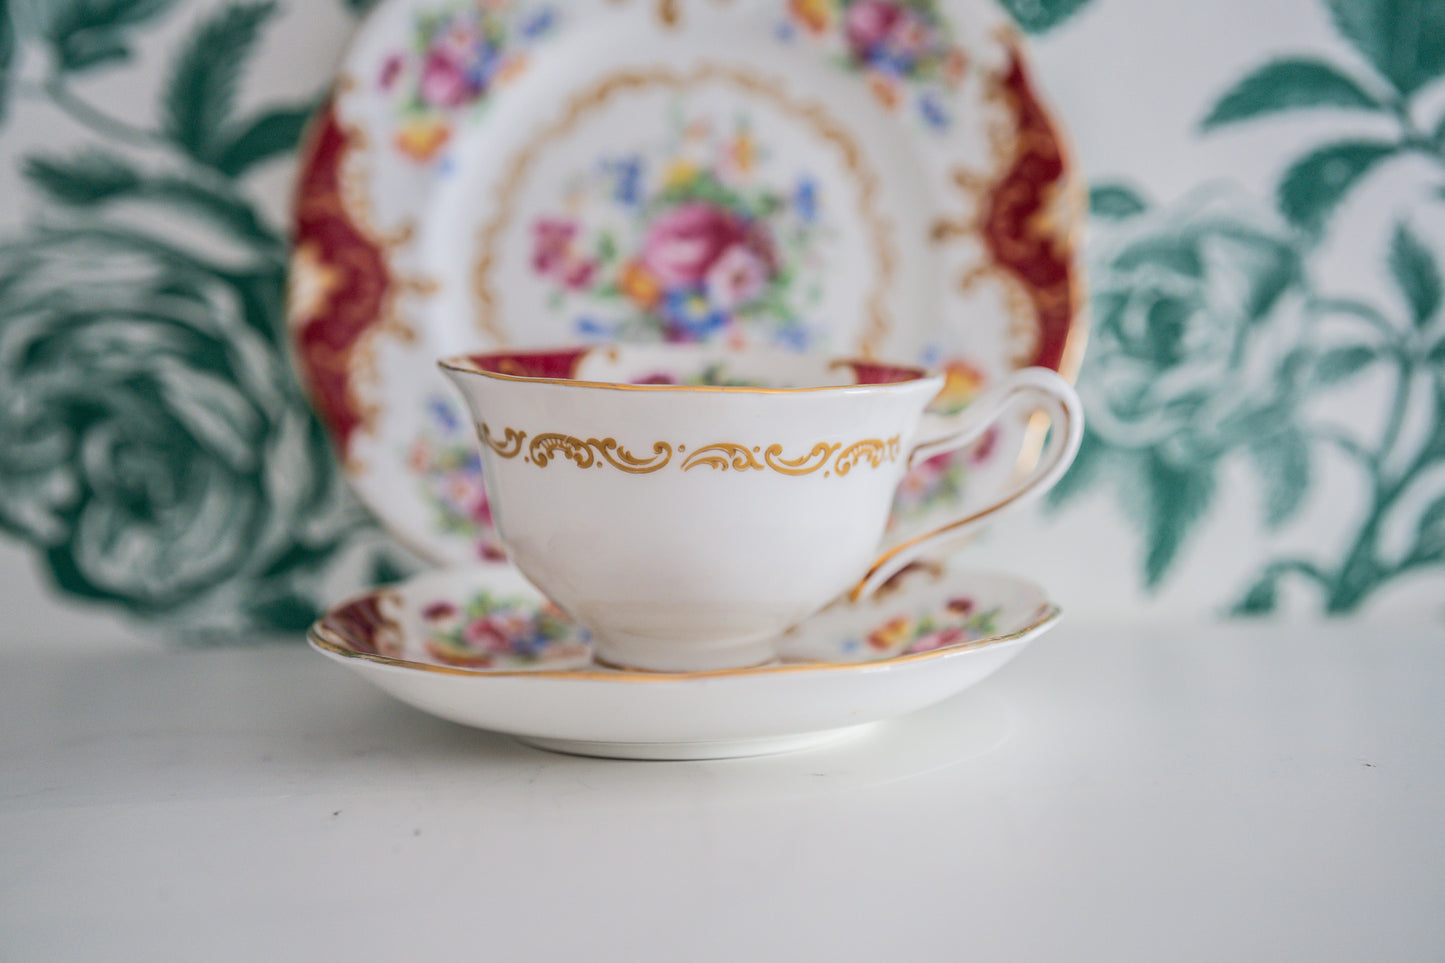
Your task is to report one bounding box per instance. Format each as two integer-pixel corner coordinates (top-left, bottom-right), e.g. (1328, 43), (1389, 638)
(532, 111), (828, 347)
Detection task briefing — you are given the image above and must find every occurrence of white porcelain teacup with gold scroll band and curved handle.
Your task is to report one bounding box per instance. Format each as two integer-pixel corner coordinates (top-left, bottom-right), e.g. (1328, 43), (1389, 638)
(441, 344), (1084, 671)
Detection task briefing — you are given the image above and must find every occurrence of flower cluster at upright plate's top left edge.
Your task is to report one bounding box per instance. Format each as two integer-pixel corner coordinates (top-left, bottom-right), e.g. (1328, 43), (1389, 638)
(376, 0), (558, 162)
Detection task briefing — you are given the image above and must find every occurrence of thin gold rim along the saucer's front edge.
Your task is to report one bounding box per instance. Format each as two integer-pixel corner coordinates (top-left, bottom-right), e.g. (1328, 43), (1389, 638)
(306, 602), (1062, 684)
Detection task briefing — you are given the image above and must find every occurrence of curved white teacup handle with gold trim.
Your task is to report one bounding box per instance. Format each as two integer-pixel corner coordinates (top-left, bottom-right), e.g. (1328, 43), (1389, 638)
(848, 367), (1084, 602)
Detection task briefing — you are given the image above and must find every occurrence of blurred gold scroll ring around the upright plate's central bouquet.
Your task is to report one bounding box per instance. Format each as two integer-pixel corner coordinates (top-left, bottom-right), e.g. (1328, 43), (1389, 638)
(471, 62), (894, 357)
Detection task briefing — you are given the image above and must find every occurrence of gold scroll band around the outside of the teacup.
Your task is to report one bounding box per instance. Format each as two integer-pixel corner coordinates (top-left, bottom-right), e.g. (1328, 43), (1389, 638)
(477, 422), (900, 476)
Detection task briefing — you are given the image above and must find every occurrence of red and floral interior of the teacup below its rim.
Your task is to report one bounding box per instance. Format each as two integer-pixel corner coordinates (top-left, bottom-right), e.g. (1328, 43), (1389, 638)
(442, 344), (928, 392)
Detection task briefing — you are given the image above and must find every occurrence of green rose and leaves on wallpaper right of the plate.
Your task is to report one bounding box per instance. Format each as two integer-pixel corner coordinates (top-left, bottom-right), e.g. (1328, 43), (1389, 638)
(1053, 0), (1445, 615)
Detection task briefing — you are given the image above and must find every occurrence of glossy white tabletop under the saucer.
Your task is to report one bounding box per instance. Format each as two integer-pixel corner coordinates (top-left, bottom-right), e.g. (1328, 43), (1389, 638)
(0, 620), (1445, 962)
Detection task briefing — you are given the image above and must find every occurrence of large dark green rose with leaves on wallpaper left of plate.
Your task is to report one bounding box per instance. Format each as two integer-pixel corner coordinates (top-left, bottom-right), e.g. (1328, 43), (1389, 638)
(0, 0), (405, 639)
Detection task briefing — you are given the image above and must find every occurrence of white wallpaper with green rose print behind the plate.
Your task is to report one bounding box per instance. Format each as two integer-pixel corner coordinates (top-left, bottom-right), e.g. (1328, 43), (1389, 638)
(0, 0), (1445, 642)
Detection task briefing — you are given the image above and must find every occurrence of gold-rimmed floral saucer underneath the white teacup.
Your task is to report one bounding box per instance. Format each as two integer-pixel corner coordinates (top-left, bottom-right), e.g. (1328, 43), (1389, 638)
(308, 564), (1059, 759)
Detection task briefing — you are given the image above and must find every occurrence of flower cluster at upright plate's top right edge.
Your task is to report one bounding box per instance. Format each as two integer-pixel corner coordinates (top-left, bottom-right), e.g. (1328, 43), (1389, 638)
(779, 0), (967, 130)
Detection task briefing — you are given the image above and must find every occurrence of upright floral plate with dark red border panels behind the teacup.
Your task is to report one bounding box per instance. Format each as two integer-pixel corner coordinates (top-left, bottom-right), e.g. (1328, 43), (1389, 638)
(289, 0), (1082, 562)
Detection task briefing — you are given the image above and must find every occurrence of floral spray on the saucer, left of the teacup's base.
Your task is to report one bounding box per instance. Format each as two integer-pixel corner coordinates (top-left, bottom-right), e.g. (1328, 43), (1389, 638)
(420, 590), (591, 669)
